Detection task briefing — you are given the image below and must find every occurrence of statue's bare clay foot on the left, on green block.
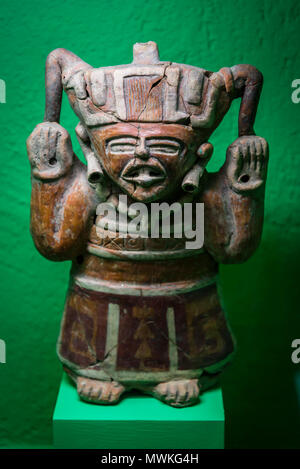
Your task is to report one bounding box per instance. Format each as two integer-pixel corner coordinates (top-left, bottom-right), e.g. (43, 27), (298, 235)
(77, 376), (125, 404)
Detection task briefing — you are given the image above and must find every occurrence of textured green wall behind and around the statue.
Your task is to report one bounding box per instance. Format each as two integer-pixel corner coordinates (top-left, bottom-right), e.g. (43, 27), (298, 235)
(0, 0), (300, 448)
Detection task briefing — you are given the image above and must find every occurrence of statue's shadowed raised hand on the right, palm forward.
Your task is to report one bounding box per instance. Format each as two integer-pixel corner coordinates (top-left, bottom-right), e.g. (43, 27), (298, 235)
(224, 135), (269, 193)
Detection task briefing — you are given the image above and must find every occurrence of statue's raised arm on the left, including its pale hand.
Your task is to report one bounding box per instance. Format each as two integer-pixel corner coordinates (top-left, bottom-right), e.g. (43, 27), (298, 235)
(27, 122), (97, 261)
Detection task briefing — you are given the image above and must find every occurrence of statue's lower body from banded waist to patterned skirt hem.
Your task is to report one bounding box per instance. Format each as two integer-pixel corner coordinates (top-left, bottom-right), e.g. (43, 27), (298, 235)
(58, 195), (233, 383)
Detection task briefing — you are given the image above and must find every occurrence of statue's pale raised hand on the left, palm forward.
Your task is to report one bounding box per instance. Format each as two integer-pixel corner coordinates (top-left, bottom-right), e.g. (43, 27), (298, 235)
(27, 122), (73, 180)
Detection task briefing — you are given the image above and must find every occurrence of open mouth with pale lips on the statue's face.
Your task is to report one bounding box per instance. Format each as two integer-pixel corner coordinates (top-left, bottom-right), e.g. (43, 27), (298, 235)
(121, 160), (166, 187)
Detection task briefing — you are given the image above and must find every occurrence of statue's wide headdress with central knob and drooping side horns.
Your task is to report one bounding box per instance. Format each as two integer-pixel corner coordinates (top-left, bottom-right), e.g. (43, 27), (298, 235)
(45, 42), (262, 136)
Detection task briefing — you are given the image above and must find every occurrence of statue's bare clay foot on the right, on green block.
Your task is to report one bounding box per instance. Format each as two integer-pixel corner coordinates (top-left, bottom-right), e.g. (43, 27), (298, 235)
(152, 379), (200, 407)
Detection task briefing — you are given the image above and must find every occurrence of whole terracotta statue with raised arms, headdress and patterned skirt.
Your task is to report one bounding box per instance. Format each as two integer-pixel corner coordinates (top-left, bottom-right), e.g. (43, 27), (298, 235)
(27, 42), (268, 407)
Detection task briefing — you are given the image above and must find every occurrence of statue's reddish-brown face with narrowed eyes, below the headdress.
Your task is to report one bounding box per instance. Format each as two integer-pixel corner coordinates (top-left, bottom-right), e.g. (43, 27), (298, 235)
(90, 123), (195, 202)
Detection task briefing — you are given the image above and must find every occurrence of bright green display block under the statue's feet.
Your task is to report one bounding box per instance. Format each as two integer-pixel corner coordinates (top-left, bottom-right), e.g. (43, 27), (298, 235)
(53, 376), (225, 449)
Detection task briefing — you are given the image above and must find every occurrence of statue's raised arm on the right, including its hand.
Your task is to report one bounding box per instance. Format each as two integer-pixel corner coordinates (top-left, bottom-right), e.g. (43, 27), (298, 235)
(203, 136), (269, 264)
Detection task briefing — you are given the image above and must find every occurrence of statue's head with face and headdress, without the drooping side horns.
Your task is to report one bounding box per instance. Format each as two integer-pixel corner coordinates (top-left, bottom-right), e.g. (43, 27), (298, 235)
(73, 42), (222, 202)
